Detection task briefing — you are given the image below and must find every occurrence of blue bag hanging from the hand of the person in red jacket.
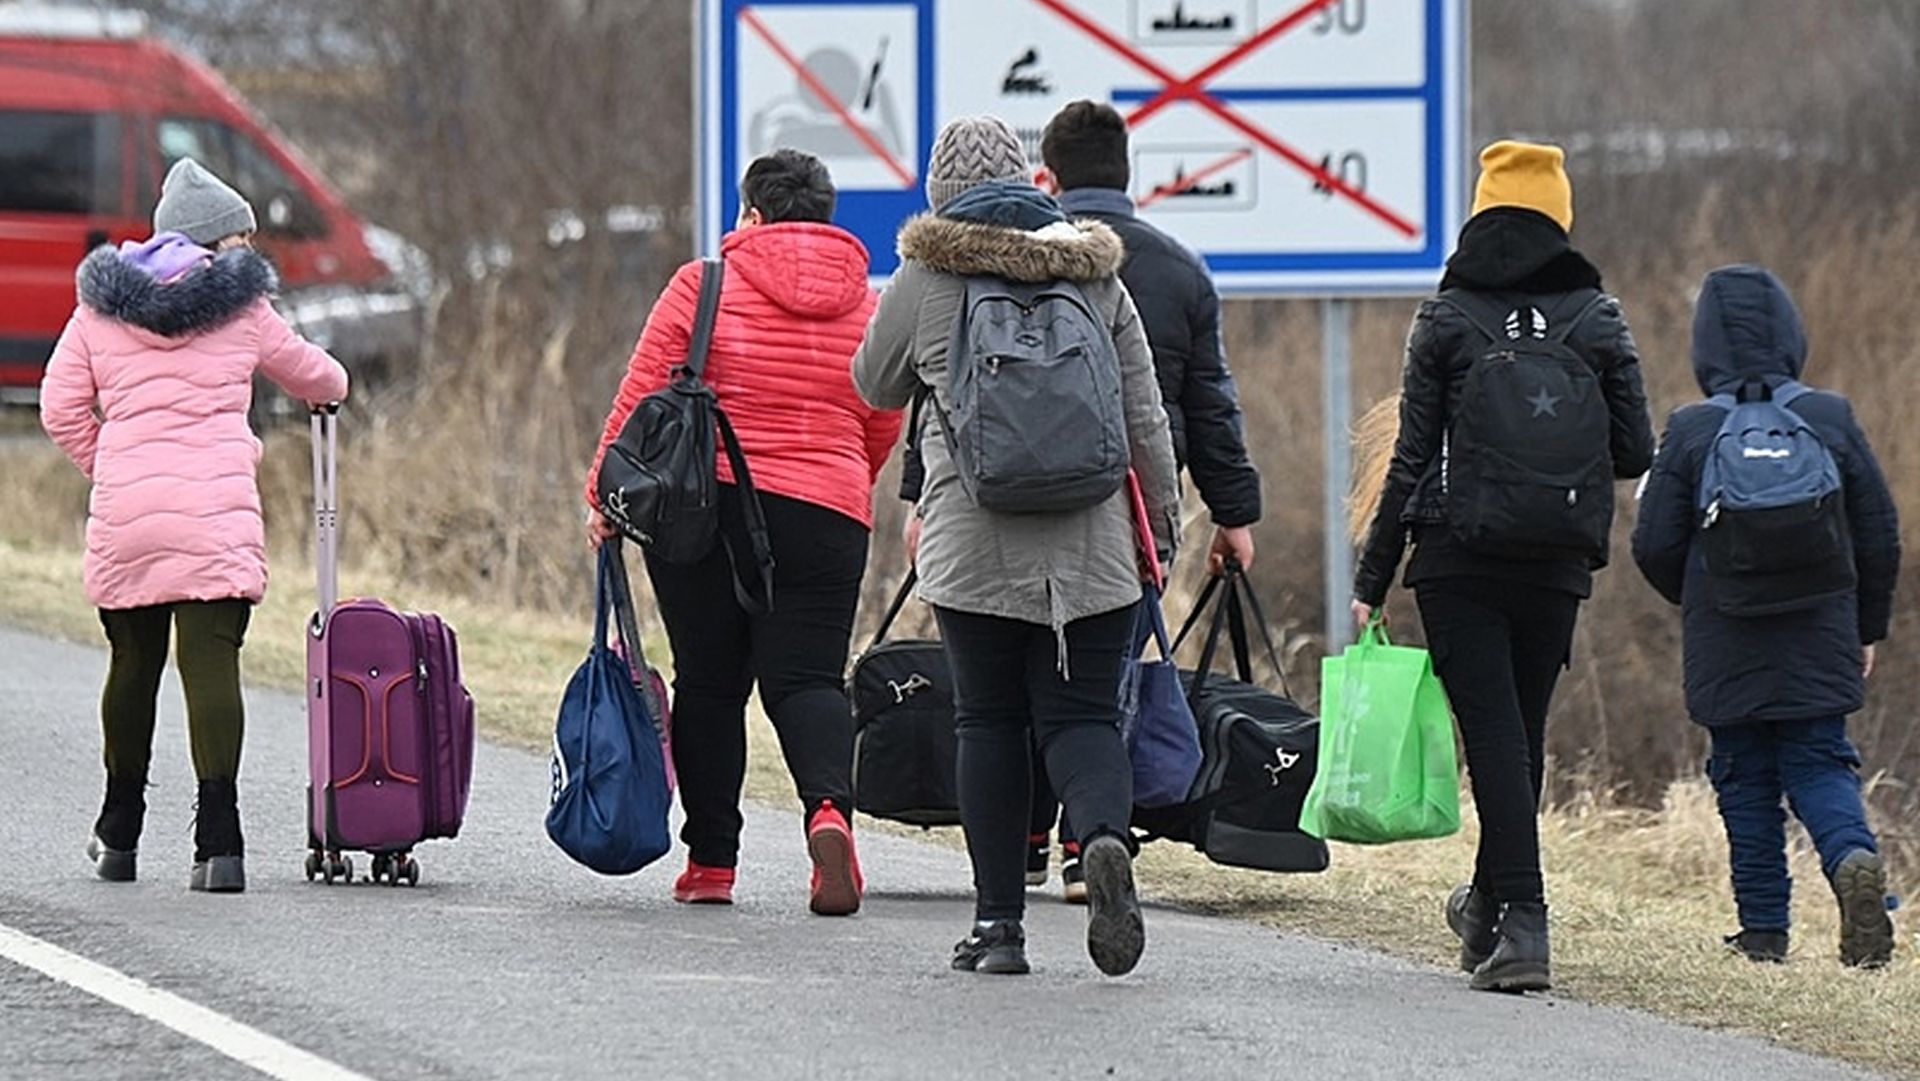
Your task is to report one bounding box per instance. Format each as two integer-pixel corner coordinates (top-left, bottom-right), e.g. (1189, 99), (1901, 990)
(547, 541), (674, 874)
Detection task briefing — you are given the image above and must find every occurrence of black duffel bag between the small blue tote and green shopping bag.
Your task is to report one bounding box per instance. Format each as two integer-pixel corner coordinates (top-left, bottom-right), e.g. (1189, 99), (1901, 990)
(1133, 563), (1327, 872)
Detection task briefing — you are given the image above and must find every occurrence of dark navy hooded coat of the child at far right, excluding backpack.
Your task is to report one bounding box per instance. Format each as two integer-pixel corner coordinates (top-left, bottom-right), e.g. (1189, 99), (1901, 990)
(1634, 267), (1901, 726)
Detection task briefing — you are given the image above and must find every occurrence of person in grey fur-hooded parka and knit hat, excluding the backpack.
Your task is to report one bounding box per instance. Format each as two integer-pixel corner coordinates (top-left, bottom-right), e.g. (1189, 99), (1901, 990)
(852, 117), (1179, 975)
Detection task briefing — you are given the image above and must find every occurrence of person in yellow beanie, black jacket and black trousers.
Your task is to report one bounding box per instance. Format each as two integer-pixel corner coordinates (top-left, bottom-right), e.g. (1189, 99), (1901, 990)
(1354, 142), (1653, 991)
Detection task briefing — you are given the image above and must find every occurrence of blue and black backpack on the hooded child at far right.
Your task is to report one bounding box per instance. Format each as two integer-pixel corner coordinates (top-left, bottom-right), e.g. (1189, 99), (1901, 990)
(1699, 382), (1859, 616)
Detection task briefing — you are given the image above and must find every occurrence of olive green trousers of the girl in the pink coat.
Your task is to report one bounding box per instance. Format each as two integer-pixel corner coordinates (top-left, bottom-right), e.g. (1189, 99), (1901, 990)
(100, 599), (253, 781)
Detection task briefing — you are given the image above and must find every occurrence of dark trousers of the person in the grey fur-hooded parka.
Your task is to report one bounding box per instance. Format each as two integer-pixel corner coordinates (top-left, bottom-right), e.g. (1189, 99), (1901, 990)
(935, 607), (1133, 920)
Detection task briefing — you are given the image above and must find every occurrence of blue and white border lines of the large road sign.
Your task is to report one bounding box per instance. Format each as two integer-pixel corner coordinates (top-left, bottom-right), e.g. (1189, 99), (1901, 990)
(695, 0), (1469, 296)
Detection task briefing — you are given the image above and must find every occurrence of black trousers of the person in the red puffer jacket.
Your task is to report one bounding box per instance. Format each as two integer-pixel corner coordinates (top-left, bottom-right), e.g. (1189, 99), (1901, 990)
(647, 486), (868, 868)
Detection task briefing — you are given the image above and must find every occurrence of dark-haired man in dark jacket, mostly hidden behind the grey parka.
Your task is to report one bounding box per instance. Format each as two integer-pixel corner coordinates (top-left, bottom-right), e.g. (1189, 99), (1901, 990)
(1027, 102), (1260, 901)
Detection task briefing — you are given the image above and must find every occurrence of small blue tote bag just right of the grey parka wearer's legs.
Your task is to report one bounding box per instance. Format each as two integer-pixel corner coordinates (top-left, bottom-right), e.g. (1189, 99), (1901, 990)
(1119, 586), (1200, 806)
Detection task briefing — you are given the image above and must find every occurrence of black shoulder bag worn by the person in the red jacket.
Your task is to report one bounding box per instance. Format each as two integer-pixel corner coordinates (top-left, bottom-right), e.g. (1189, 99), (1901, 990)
(595, 257), (774, 613)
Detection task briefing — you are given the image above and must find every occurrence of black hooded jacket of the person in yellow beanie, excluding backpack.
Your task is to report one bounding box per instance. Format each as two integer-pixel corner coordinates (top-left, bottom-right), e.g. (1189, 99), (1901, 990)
(1354, 207), (1653, 607)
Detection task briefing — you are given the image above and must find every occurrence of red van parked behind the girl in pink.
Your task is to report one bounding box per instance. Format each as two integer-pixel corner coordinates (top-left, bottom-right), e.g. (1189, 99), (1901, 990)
(0, 2), (419, 397)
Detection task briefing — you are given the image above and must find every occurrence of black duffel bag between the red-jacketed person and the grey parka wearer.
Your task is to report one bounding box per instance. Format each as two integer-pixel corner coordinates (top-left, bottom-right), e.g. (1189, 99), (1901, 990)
(847, 572), (960, 826)
